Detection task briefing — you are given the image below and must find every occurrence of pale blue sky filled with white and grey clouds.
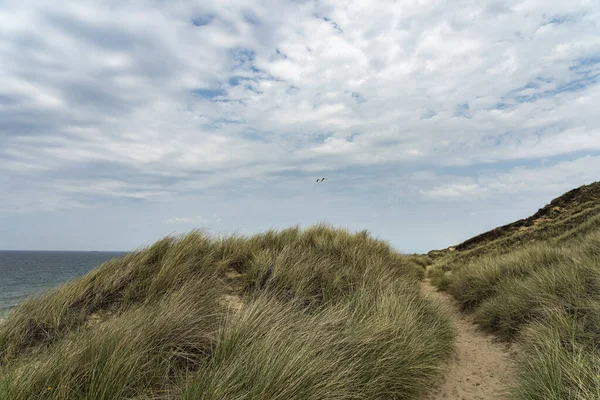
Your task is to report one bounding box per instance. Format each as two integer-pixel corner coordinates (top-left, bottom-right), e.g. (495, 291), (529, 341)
(0, 0), (600, 253)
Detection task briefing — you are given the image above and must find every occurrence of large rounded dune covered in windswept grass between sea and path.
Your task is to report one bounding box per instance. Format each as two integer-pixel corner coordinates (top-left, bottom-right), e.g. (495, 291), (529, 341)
(0, 225), (454, 400)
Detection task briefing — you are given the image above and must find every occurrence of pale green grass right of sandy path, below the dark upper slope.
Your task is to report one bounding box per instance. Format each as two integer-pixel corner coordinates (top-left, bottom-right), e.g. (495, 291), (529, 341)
(433, 228), (600, 400)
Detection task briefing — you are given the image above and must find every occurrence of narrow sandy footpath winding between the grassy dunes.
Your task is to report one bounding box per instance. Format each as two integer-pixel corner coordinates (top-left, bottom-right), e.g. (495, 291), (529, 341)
(423, 268), (518, 400)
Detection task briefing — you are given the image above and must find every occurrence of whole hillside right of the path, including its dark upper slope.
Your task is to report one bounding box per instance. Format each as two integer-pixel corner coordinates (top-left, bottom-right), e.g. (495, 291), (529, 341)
(430, 183), (600, 400)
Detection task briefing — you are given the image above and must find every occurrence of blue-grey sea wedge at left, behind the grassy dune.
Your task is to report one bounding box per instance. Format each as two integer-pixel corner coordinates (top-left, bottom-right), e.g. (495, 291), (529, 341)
(0, 251), (126, 318)
